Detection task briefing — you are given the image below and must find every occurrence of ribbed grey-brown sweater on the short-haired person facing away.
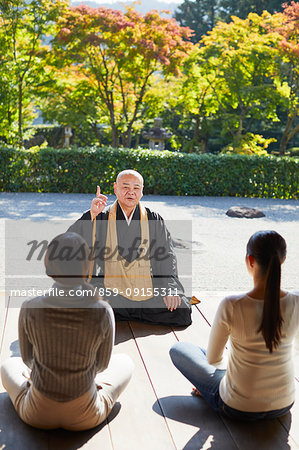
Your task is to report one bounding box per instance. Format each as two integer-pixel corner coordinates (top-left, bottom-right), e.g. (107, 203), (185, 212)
(19, 284), (115, 402)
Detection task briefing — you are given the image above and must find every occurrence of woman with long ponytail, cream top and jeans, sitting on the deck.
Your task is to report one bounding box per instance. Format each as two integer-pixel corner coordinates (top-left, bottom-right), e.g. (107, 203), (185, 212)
(170, 231), (299, 420)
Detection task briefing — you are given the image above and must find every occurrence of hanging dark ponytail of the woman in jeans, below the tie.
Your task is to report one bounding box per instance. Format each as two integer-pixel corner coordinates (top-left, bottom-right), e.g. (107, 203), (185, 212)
(258, 253), (283, 353)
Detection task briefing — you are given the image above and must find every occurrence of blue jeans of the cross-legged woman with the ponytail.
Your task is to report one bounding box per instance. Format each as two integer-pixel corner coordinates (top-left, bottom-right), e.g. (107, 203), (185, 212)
(169, 342), (292, 420)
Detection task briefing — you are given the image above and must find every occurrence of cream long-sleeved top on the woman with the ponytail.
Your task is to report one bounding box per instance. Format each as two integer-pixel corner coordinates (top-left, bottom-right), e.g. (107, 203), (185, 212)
(207, 293), (299, 412)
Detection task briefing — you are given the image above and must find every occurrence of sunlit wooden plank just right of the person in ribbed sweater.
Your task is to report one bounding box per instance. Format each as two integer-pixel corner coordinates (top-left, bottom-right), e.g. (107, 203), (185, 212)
(109, 322), (175, 450)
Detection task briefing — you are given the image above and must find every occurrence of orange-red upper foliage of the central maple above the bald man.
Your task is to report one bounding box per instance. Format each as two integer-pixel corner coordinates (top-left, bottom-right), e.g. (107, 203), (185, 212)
(57, 5), (192, 73)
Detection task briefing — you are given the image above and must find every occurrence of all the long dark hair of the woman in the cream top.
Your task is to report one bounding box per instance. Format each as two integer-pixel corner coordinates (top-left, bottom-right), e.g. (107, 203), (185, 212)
(247, 231), (287, 353)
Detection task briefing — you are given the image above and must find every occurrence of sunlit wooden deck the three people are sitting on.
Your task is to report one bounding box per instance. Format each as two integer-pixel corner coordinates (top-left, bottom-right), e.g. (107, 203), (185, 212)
(0, 294), (299, 450)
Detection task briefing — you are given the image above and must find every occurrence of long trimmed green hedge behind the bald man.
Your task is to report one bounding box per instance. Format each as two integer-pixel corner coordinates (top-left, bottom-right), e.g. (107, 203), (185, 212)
(0, 147), (299, 198)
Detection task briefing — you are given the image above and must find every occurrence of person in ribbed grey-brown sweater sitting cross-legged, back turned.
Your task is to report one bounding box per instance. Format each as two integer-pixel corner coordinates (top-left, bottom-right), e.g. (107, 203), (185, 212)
(1, 233), (133, 430)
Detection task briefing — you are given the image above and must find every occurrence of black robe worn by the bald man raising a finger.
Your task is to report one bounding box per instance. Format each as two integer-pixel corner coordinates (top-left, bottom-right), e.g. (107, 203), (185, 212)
(68, 205), (191, 326)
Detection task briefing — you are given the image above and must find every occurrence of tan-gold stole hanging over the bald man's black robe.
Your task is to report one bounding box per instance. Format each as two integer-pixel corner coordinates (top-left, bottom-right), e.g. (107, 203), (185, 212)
(104, 202), (153, 301)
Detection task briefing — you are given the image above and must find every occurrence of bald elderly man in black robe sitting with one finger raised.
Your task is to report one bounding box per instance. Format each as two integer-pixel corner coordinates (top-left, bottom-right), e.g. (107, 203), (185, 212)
(69, 170), (191, 326)
